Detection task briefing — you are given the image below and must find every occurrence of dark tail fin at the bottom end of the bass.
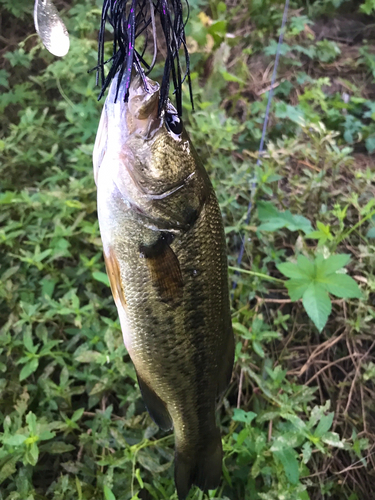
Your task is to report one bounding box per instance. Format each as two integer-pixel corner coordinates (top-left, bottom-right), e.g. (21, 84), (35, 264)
(175, 428), (223, 500)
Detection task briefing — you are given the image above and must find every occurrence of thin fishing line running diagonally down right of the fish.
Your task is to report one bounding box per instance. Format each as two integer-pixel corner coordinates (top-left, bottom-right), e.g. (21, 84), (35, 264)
(233, 0), (289, 290)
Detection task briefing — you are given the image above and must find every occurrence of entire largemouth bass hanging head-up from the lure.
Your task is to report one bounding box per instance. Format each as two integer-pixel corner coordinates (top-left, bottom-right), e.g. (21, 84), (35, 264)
(93, 74), (234, 500)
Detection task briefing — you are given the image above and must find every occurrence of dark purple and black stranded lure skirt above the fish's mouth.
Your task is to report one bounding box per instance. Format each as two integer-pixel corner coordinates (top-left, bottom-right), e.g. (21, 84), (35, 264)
(94, 0), (193, 116)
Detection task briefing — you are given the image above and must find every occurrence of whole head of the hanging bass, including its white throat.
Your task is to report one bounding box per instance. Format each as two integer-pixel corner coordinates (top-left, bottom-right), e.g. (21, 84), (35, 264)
(94, 75), (209, 227)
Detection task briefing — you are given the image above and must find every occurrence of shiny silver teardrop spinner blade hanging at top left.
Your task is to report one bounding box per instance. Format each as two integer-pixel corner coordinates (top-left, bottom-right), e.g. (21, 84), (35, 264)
(34, 0), (70, 57)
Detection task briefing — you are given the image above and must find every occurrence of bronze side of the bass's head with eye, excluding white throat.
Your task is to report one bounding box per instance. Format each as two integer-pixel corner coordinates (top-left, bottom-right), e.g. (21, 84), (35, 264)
(122, 77), (207, 215)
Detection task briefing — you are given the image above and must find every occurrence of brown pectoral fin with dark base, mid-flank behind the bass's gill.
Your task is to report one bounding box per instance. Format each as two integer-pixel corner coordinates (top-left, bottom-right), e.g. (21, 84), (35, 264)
(140, 233), (183, 306)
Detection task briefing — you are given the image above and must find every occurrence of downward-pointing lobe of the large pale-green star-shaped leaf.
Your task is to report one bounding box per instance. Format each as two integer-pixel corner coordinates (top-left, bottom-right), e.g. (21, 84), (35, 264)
(302, 282), (332, 332)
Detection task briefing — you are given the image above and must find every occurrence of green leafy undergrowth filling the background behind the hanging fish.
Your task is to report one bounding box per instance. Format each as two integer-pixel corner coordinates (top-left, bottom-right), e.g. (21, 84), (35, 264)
(0, 0), (375, 500)
